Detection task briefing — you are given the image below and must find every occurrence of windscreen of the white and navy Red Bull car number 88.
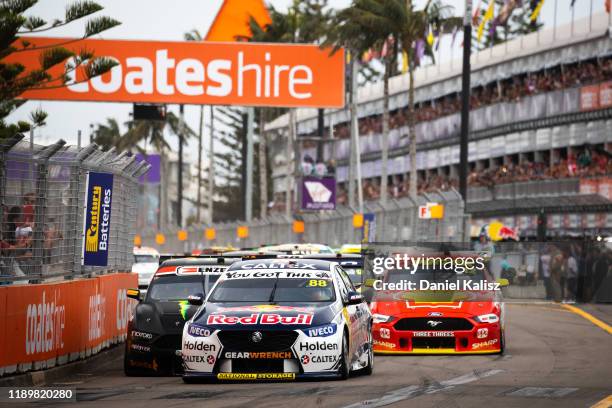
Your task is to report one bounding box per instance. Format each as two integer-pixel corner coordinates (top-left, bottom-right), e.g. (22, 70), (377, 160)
(208, 278), (336, 303)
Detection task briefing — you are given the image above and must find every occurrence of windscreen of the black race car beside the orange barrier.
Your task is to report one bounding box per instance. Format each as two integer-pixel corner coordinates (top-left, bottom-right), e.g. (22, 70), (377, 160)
(147, 274), (220, 301)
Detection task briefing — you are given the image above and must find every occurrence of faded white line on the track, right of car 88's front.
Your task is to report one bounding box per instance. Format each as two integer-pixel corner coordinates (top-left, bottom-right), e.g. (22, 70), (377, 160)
(344, 370), (504, 408)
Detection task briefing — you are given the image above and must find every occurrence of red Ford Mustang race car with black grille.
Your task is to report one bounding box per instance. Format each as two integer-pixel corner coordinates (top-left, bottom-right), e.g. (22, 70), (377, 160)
(368, 270), (507, 354)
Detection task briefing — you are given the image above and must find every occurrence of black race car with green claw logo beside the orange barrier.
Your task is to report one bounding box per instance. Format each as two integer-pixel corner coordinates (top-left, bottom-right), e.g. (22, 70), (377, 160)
(124, 257), (240, 376)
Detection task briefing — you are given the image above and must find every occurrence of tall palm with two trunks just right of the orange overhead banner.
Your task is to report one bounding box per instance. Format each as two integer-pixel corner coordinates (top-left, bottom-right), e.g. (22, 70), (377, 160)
(330, 0), (462, 198)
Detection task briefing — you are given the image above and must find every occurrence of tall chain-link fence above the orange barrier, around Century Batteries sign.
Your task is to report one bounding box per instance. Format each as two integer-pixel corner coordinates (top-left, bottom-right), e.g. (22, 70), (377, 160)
(0, 135), (149, 284)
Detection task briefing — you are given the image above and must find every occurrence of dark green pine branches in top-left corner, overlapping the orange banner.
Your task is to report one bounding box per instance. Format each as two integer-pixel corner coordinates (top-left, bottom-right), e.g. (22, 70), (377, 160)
(0, 0), (120, 139)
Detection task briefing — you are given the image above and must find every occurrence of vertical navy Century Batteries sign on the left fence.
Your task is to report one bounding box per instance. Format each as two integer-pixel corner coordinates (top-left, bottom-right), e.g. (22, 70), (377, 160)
(83, 171), (113, 266)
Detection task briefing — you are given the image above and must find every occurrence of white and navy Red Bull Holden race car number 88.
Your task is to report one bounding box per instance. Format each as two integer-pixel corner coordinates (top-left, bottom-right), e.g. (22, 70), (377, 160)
(182, 258), (374, 383)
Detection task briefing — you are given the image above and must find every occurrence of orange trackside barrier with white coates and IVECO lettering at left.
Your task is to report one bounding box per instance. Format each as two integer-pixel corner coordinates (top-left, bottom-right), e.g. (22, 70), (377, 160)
(0, 273), (138, 375)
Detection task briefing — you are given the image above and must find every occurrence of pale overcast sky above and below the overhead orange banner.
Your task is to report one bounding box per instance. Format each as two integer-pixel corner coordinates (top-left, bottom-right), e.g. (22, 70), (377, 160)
(8, 0), (604, 160)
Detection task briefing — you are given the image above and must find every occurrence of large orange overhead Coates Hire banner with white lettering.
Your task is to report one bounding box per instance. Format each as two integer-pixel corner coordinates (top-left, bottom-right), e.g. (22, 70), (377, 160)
(6, 37), (344, 108)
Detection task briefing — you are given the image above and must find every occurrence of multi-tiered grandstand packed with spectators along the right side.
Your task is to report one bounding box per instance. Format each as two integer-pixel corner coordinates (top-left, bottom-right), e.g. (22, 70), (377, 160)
(266, 14), (612, 236)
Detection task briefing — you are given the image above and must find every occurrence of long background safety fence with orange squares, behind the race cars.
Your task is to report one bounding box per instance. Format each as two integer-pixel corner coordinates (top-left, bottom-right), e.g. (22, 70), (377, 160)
(139, 190), (469, 253)
